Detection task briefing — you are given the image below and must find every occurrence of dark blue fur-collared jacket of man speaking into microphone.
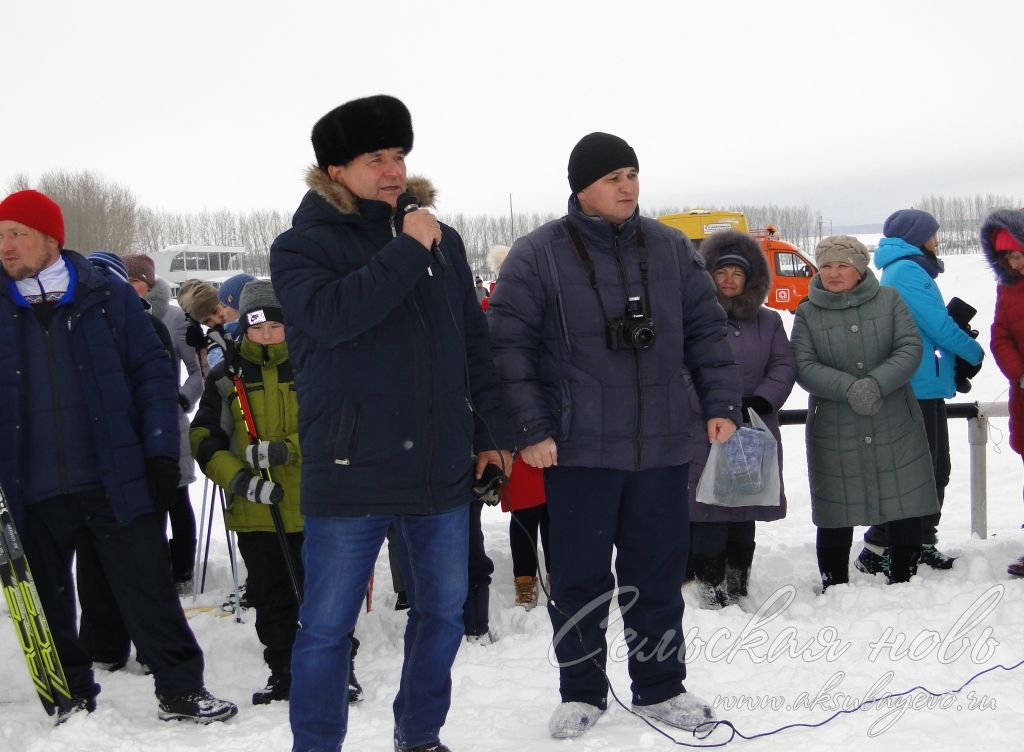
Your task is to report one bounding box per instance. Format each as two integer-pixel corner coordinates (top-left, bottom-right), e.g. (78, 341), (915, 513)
(270, 168), (512, 516)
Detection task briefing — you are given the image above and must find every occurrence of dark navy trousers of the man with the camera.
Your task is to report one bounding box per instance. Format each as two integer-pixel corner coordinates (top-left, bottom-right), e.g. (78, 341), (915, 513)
(544, 465), (689, 708)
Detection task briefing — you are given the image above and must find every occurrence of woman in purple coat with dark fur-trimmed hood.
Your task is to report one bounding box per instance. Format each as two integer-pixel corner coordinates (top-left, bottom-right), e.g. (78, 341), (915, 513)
(690, 229), (797, 609)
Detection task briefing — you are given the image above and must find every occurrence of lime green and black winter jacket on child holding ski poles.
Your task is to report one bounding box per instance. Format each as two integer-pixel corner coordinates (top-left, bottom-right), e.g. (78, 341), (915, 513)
(188, 337), (302, 533)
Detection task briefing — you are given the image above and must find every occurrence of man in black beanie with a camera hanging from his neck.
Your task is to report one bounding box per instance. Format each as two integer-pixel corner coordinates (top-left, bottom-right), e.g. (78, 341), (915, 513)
(489, 133), (741, 739)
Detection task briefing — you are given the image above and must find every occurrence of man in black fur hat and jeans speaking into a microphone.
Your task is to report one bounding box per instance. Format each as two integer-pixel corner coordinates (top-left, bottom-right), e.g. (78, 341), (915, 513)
(270, 95), (513, 752)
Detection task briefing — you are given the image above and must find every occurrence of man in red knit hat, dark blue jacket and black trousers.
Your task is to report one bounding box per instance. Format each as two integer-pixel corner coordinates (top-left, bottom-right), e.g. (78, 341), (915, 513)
(0, 191), (238, 722)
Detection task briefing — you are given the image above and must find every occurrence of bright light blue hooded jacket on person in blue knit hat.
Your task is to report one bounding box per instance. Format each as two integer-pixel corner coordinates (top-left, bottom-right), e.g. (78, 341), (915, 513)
(874, 238), (984, 400)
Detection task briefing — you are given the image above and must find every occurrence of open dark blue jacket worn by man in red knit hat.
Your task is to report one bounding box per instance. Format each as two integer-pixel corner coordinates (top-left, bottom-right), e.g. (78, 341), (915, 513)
(0, 250), (179, 524)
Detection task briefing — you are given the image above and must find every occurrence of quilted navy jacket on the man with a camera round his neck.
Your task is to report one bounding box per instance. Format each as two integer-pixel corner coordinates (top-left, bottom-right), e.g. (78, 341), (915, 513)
(489, 199), (741, 470)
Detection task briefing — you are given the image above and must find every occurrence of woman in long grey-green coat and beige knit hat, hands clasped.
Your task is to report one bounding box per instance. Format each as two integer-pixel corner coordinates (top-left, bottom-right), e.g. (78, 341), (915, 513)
(793, 236), (938, 589)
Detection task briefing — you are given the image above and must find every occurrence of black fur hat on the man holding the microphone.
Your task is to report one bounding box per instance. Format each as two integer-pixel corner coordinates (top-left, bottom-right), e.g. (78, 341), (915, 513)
(312, 94), (413, 170)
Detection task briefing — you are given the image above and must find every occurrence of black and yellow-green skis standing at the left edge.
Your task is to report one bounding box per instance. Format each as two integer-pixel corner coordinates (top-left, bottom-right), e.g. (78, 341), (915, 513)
(0, 489), (74, 716)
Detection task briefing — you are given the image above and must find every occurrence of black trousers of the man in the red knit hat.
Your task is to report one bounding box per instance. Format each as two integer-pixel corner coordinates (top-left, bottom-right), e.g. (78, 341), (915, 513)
(24, 492), (203, 697)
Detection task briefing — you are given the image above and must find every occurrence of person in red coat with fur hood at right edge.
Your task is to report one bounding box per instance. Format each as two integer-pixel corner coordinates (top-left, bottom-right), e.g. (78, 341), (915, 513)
(981, 209), (1024, 577)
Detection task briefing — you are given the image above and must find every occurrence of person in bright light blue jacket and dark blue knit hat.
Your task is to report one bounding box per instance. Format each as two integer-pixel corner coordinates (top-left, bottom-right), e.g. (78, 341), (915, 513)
(856, 209), (985, 574)
